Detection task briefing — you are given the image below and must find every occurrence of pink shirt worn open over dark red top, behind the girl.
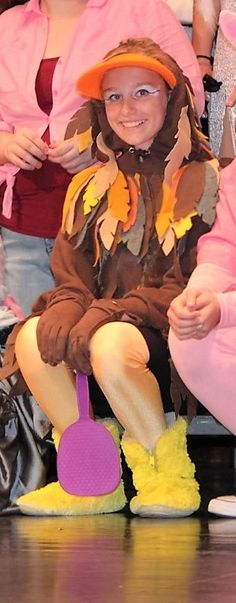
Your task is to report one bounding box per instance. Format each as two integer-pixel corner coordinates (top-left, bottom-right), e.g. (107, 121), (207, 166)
(0, 0), (204, 223)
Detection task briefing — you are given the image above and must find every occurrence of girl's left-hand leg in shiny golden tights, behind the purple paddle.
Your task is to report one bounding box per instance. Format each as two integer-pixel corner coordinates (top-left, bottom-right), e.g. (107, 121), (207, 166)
(16, 318), (78, 433)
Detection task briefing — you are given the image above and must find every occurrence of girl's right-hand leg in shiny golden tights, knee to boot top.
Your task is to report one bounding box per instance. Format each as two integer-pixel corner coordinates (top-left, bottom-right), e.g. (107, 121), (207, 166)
(90, 322), (166, 449)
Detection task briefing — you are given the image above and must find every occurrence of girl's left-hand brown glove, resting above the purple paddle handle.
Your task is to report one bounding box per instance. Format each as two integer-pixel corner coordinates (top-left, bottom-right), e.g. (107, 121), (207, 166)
(36, 300), (83, 366)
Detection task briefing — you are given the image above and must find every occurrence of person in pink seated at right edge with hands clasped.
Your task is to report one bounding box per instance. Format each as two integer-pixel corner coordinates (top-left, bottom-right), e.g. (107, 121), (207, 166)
(168, 11), (236, 517)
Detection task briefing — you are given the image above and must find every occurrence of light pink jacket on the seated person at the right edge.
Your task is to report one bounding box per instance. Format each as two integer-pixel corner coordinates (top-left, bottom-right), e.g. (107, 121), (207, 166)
(188, 159), (236, 327)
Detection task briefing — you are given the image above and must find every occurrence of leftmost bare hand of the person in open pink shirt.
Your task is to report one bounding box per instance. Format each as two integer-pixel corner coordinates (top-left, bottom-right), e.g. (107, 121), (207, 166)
(4, 128), (48, 171)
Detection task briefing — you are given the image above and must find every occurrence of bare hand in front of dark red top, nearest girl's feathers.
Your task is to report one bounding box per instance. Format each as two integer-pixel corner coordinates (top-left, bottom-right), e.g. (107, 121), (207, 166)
(48, 136), (93, 174)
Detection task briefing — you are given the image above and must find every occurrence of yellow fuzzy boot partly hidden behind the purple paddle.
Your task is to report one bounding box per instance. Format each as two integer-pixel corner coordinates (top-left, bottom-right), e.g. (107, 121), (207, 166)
(16, 420), (126, 515)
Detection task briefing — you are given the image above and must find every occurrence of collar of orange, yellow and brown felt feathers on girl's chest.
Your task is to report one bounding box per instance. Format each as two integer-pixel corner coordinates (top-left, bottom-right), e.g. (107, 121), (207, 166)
(62, 160), (218, 265)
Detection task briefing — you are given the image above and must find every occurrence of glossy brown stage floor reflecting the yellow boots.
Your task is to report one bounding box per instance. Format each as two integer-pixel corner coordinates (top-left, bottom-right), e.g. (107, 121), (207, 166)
(0, 438), (236, 603)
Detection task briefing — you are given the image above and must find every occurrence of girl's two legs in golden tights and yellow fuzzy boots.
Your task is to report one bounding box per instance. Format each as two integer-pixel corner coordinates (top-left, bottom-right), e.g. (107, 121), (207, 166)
(16, 319), (199, 516)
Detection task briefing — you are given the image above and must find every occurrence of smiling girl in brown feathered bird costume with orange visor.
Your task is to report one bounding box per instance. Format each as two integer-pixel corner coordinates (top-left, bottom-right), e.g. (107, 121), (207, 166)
(6, 39), (218, 517)
